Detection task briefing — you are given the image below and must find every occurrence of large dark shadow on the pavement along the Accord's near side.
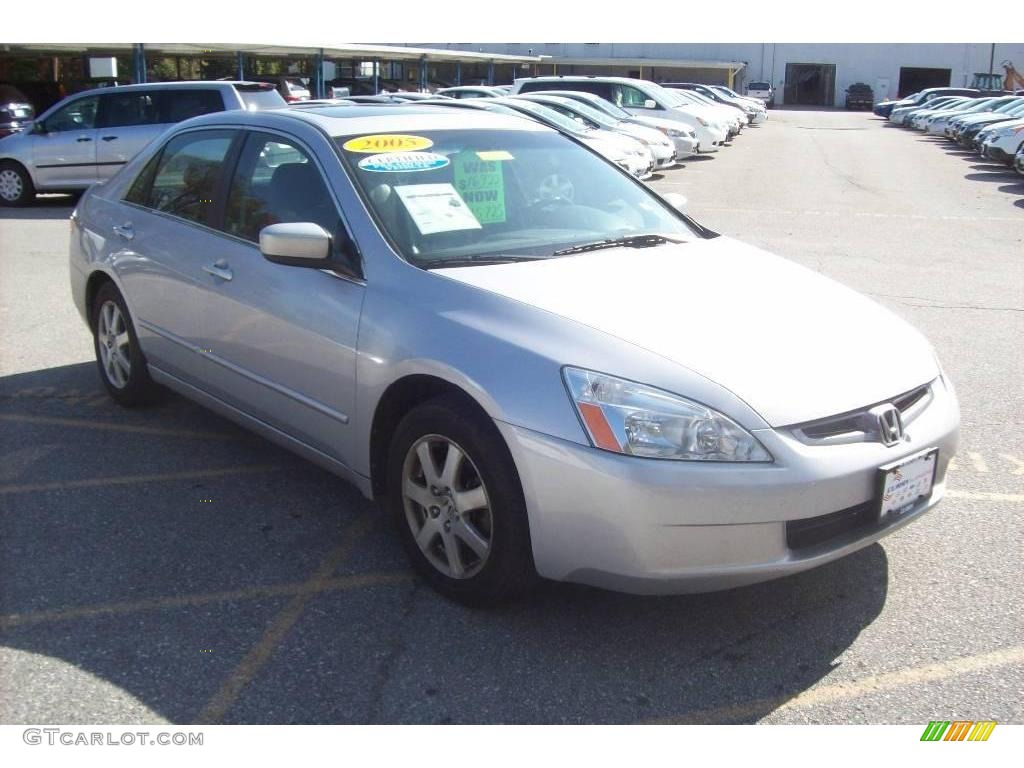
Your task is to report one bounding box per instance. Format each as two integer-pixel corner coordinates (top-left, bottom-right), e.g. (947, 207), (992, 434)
(0, 364), (888, 723)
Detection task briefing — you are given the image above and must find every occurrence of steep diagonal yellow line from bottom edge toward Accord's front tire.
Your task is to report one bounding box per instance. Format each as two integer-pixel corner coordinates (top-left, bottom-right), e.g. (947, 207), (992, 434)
(195, 514), (376, 724)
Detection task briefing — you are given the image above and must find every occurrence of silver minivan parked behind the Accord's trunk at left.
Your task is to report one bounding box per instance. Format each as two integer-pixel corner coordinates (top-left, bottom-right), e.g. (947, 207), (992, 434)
(0, 81), (286, 206)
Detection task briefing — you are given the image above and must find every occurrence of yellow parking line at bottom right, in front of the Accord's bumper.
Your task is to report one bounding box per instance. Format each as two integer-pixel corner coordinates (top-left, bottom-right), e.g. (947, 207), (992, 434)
(647, 645), (1024, 725)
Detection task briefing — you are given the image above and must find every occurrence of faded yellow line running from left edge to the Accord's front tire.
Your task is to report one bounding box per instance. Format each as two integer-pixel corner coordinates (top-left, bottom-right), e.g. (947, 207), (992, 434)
(0, 570), (413, 630)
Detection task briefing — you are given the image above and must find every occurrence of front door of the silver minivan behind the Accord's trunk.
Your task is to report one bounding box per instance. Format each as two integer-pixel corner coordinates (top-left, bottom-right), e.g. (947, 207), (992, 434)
(31, 95), (99, 188)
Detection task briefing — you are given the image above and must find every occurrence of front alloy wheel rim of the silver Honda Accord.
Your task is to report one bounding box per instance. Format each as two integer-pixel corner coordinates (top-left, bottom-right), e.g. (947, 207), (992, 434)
(401, 434), (494, 579)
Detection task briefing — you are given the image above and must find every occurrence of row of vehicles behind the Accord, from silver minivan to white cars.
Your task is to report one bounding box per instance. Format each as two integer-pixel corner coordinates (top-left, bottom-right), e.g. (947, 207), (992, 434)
(0, 77), (767, 206)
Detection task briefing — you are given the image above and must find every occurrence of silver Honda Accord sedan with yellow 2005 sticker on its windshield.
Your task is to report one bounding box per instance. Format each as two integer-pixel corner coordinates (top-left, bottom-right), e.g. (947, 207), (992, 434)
(71, 105), (959, 603)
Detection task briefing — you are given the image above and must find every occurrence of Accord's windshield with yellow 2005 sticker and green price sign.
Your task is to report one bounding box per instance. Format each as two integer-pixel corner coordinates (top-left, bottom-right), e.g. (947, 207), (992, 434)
(335, 129), (702, 268)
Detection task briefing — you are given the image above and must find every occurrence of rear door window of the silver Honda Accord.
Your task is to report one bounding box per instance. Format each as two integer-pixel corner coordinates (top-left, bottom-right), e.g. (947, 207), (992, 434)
(148, 130), (234, 224)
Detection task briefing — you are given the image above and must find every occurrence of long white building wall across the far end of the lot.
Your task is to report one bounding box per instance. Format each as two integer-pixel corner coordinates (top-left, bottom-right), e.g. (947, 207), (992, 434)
(397, 43), (1024, 106)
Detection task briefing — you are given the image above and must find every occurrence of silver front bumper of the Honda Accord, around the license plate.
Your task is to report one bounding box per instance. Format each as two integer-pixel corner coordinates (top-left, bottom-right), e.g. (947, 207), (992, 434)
(499, 378), (959, 594)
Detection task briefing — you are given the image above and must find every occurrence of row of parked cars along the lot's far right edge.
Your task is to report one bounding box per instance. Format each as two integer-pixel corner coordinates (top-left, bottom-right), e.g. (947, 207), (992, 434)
(874, 88), (1024, 175)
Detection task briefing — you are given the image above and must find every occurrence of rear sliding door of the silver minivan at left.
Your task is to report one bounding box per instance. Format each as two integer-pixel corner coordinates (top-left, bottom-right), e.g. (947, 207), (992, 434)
(96, 89), (167, 179)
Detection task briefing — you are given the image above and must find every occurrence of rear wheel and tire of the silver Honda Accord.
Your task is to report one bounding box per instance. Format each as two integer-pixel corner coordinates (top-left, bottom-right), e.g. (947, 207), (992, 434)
(92, 283), (161, 407)
